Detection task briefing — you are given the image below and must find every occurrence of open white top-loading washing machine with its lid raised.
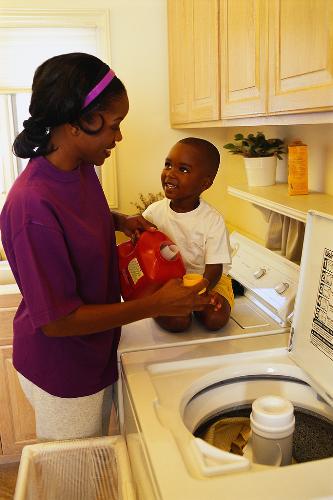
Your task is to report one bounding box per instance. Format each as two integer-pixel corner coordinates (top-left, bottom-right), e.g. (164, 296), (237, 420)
(121, 212), (333, 500)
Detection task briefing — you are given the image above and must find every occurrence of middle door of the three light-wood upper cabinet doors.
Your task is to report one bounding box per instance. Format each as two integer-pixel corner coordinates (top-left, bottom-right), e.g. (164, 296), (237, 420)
(221, 0), (268, 118)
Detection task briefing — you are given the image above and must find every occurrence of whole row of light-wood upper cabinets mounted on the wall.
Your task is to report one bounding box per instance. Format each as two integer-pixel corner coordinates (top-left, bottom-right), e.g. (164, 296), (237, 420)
(168, 0), (333, 126)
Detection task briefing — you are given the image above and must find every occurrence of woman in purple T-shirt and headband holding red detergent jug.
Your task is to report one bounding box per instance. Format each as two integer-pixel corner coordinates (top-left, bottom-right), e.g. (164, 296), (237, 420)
(0, 53), (211, 439)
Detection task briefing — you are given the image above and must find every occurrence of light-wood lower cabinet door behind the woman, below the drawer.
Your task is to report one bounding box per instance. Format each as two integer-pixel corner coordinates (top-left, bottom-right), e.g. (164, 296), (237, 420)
(0, 346), (36, 455)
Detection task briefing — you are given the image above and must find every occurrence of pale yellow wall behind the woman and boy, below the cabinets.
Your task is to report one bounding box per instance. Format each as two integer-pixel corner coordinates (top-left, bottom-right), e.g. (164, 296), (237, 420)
(4, 0), (333, 246)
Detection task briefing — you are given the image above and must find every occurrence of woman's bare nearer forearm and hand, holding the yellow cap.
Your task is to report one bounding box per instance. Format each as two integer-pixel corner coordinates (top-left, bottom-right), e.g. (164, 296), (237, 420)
(42, 279), (212, 337)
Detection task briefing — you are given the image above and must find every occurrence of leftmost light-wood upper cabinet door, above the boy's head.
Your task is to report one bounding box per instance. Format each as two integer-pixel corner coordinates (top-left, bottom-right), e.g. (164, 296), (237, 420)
(168, 0), (220, 125)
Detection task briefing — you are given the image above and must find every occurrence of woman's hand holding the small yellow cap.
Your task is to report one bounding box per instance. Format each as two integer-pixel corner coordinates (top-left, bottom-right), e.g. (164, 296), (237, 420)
(150, 278), (215, 317)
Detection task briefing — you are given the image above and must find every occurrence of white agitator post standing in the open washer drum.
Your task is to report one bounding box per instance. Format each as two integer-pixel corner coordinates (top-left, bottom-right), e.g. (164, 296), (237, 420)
(250, 396), (295, 466)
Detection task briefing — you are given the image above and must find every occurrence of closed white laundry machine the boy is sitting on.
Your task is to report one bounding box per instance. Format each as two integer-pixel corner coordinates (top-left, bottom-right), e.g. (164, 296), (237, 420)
(118, 232), (299, 429)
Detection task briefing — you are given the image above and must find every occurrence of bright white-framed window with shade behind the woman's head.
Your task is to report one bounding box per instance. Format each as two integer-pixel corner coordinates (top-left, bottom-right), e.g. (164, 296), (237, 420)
(0, 9), (117, 207)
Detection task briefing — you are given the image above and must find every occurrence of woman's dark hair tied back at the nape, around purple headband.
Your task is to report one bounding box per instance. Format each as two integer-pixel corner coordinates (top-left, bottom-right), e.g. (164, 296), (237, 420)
(13, 52), (126, 158)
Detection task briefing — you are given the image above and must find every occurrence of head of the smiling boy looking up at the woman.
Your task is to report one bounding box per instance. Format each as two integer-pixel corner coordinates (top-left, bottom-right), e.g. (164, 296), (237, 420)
(161, 137), (220, 210)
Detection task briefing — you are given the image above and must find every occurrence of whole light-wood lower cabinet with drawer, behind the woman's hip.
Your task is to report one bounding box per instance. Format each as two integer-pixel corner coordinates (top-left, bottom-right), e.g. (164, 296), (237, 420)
(0, 293), (36, 460)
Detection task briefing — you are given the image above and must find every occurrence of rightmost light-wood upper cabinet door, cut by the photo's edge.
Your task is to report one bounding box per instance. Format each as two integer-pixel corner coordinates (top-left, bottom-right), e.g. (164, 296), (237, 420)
(269, 0), (333, 113)
